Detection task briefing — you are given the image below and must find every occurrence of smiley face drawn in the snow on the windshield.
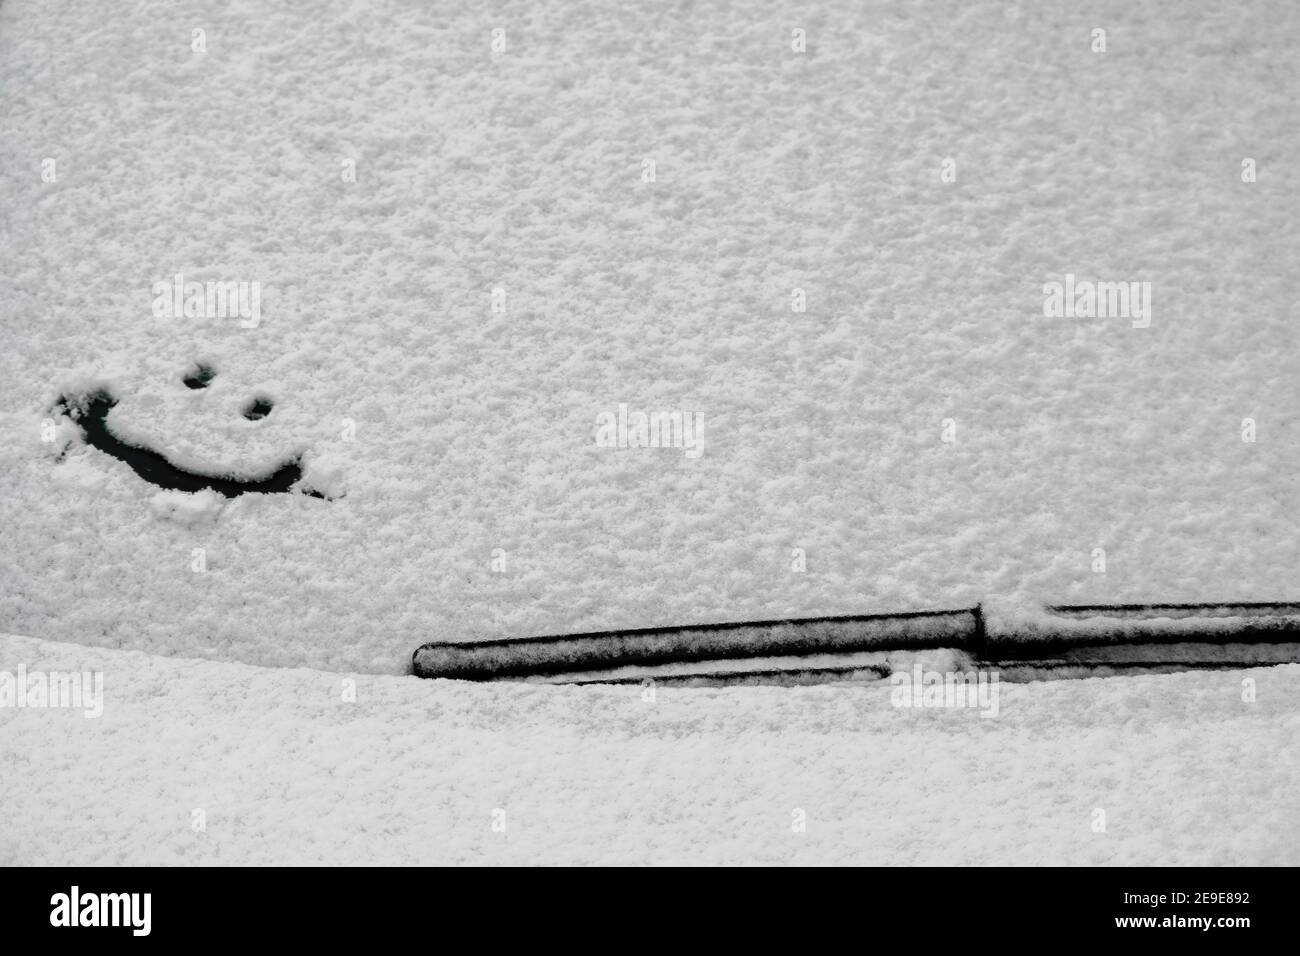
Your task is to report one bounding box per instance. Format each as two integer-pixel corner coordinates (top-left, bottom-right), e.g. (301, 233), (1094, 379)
(55, 363), (325, 498)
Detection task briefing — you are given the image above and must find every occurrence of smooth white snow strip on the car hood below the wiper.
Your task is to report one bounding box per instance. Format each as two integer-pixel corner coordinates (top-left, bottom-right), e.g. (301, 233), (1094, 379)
(0, 636), (1300, 865)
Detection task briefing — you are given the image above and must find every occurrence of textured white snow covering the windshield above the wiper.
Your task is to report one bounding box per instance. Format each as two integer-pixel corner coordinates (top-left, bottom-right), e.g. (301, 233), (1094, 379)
(0, 0), (1300, 674)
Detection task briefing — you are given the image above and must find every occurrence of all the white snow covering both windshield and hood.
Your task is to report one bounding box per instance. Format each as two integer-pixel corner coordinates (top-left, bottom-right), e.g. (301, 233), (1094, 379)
(0, 0), (1300, 864)
